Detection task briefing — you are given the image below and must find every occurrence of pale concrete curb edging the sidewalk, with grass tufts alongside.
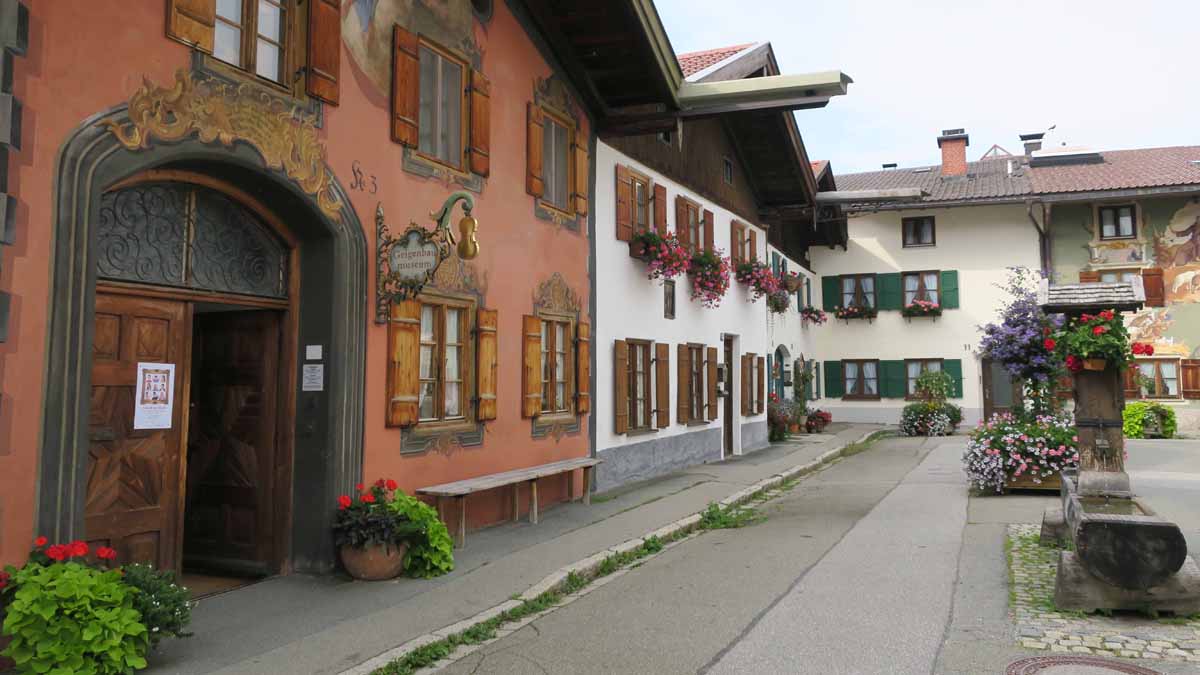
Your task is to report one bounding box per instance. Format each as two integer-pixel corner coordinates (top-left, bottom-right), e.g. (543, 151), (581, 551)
(341, 429), (887, 675)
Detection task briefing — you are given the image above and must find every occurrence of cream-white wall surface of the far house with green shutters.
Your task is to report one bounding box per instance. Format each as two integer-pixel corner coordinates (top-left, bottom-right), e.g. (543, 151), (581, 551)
(809, 204), (1040, 424)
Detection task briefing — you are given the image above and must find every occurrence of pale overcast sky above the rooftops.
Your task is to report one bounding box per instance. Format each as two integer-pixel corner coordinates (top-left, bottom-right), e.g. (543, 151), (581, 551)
(656, 0), (1200, 173)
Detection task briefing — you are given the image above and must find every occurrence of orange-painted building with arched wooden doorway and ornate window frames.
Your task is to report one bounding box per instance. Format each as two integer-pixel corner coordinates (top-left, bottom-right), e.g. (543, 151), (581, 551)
(0, 0), (648, 573)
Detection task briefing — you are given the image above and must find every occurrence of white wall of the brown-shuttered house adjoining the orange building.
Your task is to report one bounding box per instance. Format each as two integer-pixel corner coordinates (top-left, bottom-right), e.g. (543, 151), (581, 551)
(593, 142), (769, 458)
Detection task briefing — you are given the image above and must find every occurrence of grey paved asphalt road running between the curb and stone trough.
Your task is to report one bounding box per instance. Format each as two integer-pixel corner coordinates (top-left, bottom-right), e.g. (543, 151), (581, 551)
(445, 437), (1200, 675)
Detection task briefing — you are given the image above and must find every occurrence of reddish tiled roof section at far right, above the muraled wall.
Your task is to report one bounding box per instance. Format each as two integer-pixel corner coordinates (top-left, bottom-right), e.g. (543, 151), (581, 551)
(1028, 145), (1200, 193)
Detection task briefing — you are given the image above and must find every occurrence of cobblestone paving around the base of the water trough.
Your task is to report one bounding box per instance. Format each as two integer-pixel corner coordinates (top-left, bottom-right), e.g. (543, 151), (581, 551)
(1008, 524), (1200, 664)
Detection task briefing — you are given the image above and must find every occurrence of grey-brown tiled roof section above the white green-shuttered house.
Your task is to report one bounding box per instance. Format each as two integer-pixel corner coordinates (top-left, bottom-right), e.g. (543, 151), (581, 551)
(838, 157), (1033, 203)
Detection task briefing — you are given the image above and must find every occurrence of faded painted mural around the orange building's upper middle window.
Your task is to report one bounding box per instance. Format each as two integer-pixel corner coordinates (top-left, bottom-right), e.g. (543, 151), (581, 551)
(342, 0), (486, 106)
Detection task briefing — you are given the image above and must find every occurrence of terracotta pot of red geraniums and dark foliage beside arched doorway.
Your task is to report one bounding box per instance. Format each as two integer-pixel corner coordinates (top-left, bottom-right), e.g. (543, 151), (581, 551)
(334, 478), (421, 581)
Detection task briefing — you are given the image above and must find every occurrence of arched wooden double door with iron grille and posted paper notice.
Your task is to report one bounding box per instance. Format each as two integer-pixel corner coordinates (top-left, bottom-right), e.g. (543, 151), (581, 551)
(84, 174), (296, 573)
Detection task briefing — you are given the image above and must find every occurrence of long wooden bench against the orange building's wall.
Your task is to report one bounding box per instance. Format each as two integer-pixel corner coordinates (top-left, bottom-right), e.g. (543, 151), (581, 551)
(416, 458), (604, 548)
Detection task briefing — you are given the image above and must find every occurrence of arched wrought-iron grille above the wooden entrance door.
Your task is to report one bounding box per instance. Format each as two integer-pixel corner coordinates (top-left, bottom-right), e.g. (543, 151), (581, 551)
(96, 183), (288, 298)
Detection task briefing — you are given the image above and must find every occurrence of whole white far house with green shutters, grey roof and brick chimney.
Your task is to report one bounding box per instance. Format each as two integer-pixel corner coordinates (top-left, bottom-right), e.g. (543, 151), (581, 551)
(810, 130), (1042, 424)
